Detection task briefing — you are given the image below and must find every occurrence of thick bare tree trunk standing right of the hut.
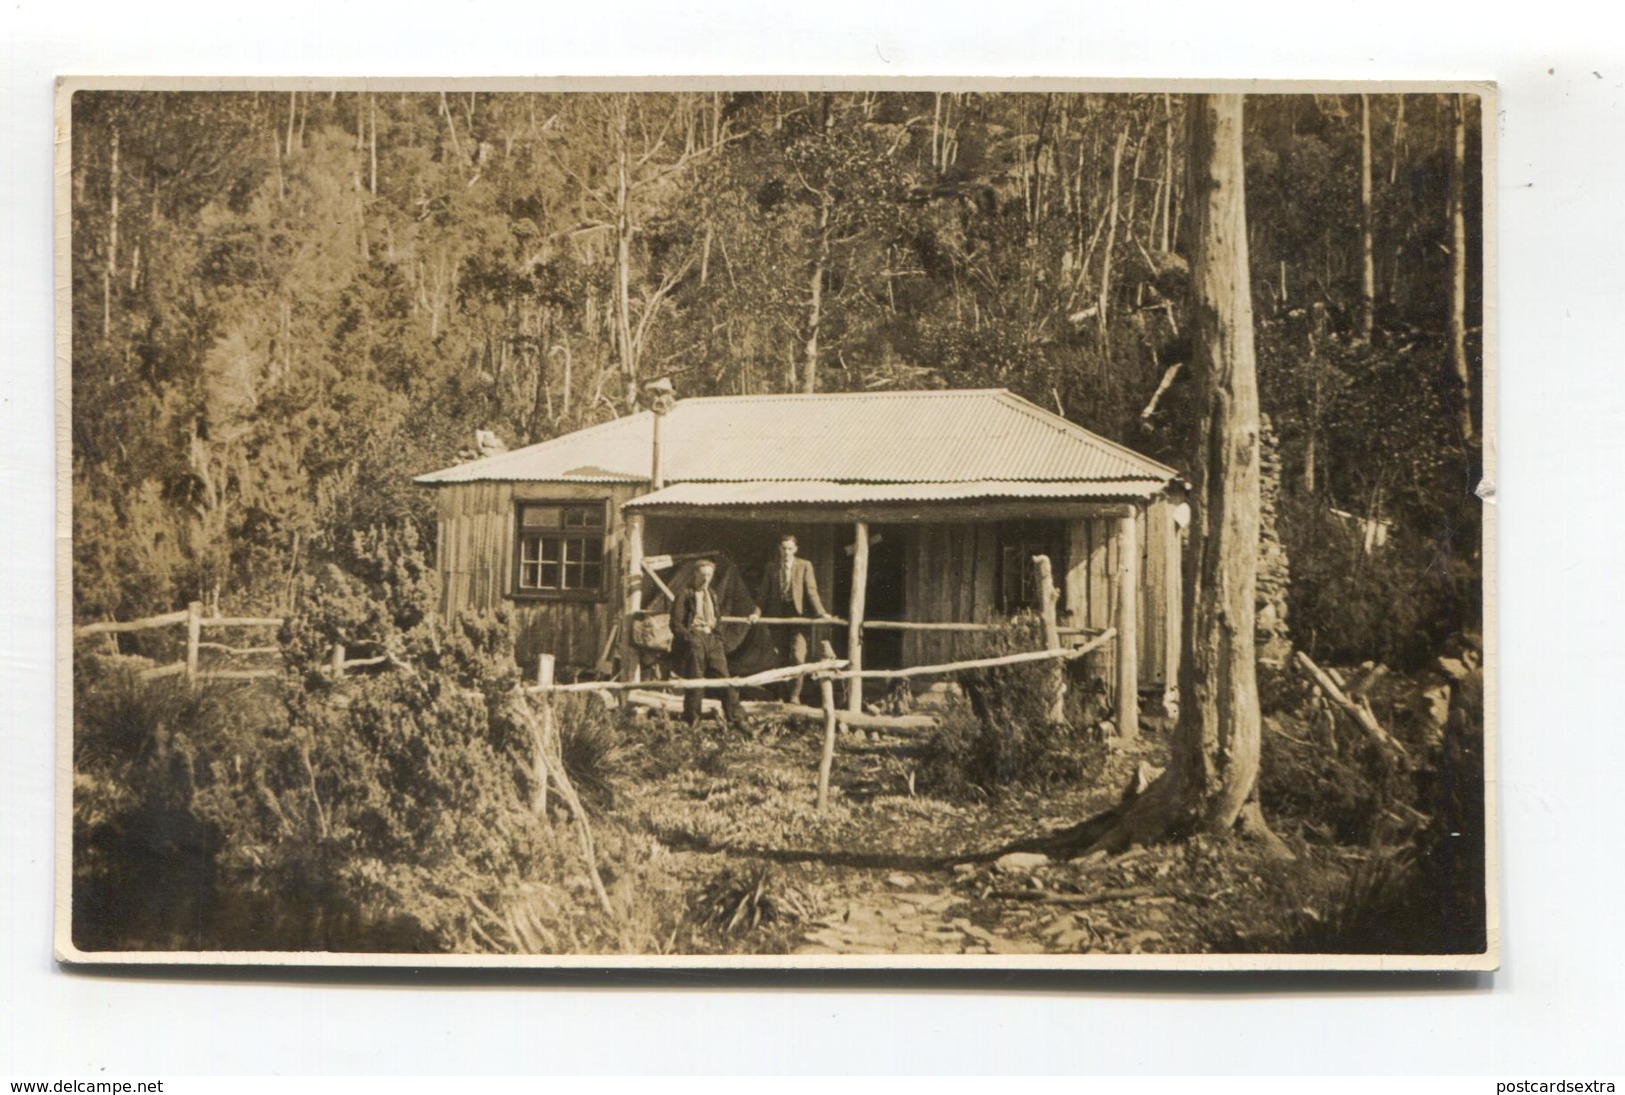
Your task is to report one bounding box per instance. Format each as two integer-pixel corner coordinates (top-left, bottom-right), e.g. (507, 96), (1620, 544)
(1094, 96), (1268, 851)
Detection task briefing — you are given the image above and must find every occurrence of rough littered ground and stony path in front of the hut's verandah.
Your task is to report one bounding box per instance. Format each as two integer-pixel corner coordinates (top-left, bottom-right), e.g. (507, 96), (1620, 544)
(614, 714), (1202, 955)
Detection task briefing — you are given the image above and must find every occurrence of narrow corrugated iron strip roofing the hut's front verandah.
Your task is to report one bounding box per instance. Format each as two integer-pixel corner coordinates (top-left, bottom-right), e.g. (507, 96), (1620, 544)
(626, 479), (1167, 509)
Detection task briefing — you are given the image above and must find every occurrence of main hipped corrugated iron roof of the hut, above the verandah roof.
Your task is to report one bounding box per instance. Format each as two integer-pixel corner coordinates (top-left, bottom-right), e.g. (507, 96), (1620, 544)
(418, 388), (1177, 484)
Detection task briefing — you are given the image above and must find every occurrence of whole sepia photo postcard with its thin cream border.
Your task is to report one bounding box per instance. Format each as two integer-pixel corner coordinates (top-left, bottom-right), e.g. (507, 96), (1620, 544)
(57, 80), (1500, 970)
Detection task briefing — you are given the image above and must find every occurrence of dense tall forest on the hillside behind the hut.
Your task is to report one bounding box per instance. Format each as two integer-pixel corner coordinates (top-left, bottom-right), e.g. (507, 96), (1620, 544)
(72, 91), (1480, 656)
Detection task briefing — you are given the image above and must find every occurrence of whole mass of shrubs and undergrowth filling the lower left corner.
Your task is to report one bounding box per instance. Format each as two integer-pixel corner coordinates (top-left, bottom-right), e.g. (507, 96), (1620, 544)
(75, 531), (640, 952)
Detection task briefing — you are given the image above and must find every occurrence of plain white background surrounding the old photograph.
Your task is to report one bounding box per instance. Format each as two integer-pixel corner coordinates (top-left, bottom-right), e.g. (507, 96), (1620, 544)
(0, 0), (1625, 1077)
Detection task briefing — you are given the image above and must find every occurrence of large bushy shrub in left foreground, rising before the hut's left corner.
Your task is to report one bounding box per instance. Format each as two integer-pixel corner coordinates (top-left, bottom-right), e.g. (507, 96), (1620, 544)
(209, 555), (561, 950)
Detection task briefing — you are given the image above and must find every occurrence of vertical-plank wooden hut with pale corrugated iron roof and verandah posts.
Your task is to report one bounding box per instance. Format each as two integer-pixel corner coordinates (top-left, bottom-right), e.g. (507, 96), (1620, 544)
(418, 390), (1185, 714)
